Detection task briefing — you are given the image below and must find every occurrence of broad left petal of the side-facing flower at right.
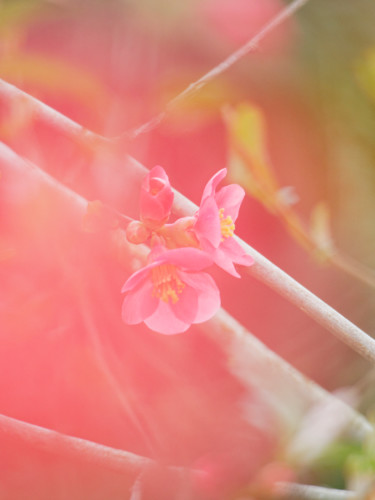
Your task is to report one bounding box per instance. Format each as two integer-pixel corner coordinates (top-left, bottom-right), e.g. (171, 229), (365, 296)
(194, 197), (221, 247)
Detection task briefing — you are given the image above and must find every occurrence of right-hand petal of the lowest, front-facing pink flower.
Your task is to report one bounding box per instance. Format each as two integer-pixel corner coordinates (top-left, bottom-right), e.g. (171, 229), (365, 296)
(180, 273), (220, 323)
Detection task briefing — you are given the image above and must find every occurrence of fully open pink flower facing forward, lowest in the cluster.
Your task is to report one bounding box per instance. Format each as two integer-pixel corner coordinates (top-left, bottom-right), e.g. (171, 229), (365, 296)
(122, 246), (220, 335)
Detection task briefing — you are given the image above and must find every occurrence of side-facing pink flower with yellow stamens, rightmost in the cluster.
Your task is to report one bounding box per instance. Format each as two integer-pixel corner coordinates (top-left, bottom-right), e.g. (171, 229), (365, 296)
(194, 168), (254, 277)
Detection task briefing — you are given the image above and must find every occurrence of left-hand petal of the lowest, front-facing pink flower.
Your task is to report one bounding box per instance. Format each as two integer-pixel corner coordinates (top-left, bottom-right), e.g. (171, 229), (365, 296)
(122, 281), (158, 325)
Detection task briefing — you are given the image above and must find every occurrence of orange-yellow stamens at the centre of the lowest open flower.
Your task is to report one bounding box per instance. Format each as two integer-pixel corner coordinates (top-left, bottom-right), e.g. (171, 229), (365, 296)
(151, 264), (185, 304)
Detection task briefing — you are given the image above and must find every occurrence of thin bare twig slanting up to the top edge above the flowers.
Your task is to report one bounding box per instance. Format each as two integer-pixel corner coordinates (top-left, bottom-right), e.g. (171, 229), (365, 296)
(124, 0), (308, 141)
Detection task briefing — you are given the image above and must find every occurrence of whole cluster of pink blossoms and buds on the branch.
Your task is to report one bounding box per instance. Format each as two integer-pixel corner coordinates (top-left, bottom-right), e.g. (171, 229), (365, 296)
(122, 166), (253, 335)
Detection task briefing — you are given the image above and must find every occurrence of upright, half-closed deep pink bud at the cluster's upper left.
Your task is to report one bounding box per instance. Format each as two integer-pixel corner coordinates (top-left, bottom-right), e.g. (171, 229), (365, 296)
(140, 166), (174, 229)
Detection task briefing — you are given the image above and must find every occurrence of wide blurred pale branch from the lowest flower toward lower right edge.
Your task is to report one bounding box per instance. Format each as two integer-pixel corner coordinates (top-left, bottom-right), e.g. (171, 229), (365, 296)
(207, 309), (373, 441)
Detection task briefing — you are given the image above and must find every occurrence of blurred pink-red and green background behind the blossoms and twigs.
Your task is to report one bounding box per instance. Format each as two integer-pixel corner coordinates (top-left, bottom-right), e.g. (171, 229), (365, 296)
(0, 0), (375, 499)
